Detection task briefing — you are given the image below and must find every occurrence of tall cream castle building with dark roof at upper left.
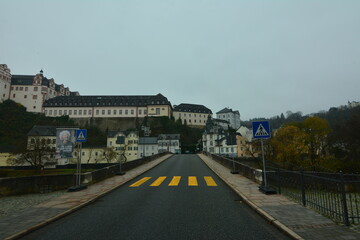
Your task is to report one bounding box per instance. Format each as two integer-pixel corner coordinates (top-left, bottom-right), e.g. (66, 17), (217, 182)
(9, 70), (79, 112)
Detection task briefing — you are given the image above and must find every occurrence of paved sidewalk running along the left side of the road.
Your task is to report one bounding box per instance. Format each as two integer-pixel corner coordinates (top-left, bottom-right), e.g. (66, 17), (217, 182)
(0, 154), (172, 240)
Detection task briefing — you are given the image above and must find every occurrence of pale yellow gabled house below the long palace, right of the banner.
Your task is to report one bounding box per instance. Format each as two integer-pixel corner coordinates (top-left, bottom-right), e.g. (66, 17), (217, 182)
(107, 131), (140, 161)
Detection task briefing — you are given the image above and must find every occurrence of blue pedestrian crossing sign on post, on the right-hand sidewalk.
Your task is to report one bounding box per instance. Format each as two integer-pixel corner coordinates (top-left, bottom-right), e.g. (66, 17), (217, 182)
(252, 121), (276, 194)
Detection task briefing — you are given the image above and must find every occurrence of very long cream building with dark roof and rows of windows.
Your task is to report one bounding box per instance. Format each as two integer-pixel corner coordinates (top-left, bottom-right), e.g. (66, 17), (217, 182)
(43, 94), (172, 118)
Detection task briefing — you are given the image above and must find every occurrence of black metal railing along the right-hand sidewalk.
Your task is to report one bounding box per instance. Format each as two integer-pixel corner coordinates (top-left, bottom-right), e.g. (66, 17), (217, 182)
(205, 153), (360, 225)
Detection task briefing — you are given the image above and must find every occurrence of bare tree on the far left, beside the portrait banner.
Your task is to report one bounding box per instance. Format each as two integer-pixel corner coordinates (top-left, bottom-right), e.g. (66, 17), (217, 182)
(7, 137), (56, 170)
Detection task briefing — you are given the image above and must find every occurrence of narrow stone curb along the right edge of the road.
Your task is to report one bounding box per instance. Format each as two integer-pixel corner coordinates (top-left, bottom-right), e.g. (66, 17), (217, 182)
(198, 154), (304, 240)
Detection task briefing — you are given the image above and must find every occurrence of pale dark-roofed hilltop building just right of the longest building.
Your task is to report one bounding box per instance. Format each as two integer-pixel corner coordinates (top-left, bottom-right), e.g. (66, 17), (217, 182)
(173, 103), (212, 127)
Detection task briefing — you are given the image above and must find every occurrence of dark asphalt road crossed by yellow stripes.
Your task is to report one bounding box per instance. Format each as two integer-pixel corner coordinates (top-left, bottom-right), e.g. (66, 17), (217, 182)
(22, 154), (289, 240)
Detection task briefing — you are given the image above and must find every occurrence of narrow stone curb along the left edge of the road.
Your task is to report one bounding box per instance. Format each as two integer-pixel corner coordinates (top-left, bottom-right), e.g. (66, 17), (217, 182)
(4, 154), (173, 240)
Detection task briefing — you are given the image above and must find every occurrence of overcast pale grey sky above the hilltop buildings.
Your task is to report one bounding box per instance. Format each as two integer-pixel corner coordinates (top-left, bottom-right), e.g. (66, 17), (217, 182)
(0, 0), (360, 120)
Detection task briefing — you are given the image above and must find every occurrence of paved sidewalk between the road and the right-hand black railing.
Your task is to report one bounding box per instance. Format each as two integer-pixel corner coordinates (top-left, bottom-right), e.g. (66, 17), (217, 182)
(198, 154), (360, 240)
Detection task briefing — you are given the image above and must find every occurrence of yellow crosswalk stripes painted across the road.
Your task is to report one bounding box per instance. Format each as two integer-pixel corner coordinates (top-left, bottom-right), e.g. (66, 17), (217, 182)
(129, 176), (217, 187)
